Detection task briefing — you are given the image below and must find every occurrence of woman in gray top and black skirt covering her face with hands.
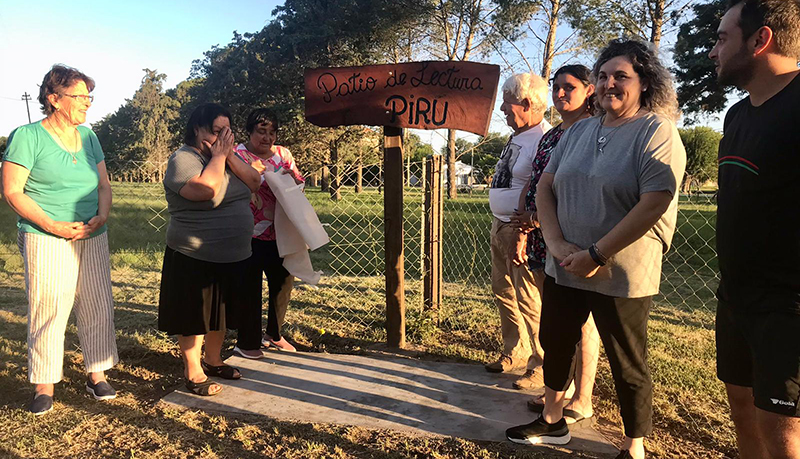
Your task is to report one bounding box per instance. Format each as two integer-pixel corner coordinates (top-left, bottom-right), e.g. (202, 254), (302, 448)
(158, 104), (261, 395)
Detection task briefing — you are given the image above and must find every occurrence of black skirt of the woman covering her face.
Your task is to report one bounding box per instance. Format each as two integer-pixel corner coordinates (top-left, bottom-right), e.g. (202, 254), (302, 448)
(158, 247), (247, 336)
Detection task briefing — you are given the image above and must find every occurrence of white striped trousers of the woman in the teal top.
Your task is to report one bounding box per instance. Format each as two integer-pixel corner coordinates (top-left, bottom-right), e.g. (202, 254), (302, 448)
(17, 233), (119, 384)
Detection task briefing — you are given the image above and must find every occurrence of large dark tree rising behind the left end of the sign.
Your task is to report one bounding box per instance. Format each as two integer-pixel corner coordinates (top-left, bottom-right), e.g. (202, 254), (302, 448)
(191, 0), (426, 177)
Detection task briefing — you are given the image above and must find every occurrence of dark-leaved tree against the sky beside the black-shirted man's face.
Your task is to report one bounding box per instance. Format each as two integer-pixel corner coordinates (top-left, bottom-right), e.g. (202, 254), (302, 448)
(674, 0), (727, 120)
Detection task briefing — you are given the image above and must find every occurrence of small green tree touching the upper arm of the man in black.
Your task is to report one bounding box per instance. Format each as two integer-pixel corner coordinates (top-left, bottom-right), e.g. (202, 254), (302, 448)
(679, 126), (722, 193)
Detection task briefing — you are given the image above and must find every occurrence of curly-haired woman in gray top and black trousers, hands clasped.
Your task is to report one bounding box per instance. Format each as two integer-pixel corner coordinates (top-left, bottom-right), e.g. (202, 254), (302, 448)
(506, 39), (686, 459)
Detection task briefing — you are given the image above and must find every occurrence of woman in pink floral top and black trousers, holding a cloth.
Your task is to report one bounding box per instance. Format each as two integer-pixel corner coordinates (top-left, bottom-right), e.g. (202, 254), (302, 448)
(234, 108), (304, 359)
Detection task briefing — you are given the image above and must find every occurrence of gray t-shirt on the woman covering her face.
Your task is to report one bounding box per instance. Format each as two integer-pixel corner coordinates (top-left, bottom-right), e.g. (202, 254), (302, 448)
(164, 145), (253, 263)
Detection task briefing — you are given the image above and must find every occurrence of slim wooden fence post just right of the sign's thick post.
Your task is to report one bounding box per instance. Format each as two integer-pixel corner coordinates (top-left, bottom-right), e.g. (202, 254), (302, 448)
(422, 155), (444, 311)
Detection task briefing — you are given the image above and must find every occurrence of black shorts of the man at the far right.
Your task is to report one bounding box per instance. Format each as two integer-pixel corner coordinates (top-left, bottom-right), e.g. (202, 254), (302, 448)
(716, 301), (800, 417)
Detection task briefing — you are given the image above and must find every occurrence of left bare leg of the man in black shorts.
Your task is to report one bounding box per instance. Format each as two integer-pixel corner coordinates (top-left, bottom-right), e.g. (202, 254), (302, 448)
(725, 384), (769, 459)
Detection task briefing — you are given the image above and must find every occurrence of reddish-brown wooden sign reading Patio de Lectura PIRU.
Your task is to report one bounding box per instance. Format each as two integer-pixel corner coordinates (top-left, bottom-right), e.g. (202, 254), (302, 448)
(305, 61), (500, 135)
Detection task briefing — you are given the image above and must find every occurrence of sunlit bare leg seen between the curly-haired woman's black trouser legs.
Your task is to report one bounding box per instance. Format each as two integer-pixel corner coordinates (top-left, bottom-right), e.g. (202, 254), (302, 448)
(566, 314), (600, 417)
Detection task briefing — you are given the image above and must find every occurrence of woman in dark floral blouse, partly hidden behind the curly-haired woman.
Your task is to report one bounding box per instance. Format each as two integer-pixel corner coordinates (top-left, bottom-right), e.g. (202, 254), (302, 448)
(512, 65), (600, 423)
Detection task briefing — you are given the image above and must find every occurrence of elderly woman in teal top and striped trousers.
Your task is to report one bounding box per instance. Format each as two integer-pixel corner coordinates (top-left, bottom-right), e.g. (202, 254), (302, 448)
(3, 65), (118, 415)
